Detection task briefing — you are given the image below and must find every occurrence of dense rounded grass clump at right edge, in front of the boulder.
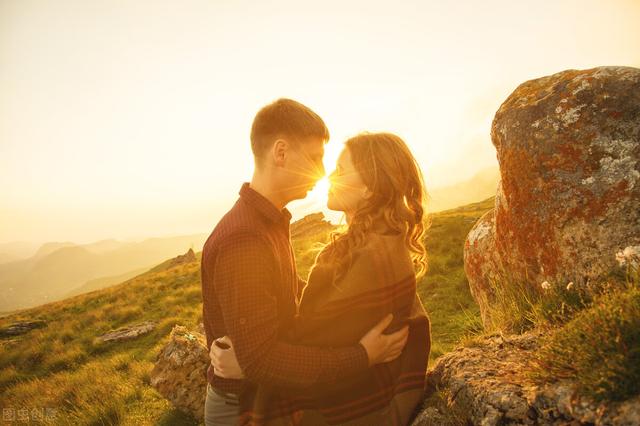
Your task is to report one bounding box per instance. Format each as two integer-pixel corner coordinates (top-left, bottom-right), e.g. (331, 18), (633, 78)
(529, 281), (640, 402)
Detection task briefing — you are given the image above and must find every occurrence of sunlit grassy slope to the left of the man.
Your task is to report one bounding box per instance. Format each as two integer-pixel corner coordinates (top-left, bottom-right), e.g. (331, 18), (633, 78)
(0, 262), (202, 425)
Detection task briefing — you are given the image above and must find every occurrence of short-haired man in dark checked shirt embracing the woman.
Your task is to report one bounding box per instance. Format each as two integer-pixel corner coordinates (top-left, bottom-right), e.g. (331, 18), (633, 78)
(201, 99), (407, 426)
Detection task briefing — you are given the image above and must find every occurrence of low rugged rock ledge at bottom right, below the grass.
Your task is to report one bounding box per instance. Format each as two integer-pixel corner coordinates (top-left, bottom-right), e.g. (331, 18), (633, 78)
(413, 332), (640, 426)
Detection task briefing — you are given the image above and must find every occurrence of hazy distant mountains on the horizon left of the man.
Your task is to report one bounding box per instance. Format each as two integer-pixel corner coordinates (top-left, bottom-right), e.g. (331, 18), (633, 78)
(0, 234), (208, 312)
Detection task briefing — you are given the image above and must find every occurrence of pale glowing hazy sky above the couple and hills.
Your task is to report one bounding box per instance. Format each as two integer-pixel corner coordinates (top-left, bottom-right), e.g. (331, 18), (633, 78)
(0, 0), (640, 243)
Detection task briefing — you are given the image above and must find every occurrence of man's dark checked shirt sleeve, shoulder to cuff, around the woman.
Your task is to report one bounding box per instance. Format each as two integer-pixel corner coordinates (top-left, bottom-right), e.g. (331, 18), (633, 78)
(213, 231), (369, 388)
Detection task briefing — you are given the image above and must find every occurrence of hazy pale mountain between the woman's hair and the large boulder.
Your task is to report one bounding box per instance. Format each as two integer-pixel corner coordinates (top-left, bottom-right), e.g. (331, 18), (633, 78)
(427, 166), (500, 213)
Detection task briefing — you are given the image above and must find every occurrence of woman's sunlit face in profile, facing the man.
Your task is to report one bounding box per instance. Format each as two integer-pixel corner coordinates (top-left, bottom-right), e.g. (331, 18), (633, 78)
(327, 146), (369, 215)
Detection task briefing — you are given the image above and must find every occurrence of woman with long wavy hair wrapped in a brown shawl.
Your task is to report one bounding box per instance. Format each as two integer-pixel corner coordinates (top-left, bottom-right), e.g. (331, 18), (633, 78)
(214, 133), (431, 426)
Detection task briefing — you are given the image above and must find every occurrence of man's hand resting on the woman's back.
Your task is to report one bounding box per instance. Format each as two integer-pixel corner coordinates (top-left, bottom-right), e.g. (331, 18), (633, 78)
(360, 314), (409, 366)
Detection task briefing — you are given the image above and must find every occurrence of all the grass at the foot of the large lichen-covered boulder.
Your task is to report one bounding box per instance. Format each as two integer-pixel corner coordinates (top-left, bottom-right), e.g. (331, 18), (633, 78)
(478, 241), (640, 402)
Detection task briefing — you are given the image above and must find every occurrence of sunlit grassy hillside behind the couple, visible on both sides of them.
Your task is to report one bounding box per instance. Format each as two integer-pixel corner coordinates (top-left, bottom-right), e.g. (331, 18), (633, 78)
(0, 199), (493, 425)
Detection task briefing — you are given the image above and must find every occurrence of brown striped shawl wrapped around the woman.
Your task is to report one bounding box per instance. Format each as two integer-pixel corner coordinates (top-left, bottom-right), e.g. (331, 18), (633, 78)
(236, 233), (431, 426)
